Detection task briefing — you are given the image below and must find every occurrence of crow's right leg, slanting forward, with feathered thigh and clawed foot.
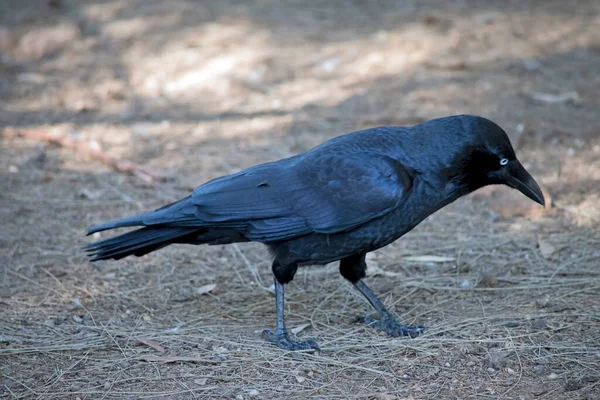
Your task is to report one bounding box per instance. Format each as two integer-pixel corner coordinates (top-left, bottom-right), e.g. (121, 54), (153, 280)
(340, 254), (425, 338)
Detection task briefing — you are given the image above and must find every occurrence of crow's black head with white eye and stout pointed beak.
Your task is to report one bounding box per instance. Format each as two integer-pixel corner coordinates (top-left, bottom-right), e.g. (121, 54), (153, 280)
(440, 115), (545, 206)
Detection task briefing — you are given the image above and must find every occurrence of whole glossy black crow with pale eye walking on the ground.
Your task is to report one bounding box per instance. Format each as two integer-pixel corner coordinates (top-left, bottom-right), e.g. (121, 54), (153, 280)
(86, 115), (544, 350)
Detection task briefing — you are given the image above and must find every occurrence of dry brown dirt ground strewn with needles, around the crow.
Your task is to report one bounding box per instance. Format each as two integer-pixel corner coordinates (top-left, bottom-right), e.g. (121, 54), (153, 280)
(0, 0), (600, 399)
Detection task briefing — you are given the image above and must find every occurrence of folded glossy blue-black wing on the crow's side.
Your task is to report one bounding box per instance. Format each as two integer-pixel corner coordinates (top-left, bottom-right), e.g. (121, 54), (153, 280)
(169, 154), (412, 242)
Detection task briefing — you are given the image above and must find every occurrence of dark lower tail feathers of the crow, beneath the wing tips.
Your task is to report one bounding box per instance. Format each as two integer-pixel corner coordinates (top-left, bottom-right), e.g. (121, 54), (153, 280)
(85, 225), (202, 261)
